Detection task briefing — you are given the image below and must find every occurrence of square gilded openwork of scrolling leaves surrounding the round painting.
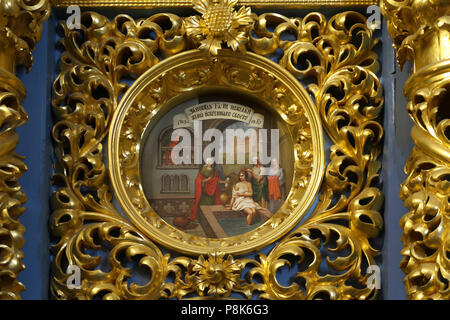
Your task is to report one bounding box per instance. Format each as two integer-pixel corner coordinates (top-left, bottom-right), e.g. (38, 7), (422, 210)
(50, 0), (384, 299)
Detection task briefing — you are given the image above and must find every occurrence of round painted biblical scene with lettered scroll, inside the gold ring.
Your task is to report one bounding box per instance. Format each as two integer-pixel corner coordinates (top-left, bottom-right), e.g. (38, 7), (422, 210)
(141, 94), (294, 238)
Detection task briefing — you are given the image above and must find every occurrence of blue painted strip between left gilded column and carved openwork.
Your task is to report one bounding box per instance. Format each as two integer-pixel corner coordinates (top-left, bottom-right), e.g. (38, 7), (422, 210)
(17, 16), (54, 299)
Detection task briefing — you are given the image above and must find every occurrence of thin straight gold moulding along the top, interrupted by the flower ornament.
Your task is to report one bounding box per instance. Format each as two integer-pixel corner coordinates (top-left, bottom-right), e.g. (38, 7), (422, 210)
(52, 0), (378, 9)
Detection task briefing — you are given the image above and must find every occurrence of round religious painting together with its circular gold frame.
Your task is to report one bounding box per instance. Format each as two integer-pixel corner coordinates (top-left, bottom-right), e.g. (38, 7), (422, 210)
(108, 50), (325, 254)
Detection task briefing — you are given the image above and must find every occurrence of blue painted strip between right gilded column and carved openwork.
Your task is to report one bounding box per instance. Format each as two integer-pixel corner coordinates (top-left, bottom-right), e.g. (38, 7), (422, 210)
(381, 19), (413, 300)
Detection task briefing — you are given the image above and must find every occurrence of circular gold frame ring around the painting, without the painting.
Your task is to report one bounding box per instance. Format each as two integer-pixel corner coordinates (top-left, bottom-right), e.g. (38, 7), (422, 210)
(108, 50), (325, 255)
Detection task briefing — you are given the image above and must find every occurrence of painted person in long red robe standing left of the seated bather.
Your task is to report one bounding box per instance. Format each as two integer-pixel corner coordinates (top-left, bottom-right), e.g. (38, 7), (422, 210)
(189, 158), (224, 220)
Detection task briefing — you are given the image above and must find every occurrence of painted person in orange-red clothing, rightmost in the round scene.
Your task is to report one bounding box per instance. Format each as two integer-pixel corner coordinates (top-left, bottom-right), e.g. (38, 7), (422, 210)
(267, 158), (285, 213)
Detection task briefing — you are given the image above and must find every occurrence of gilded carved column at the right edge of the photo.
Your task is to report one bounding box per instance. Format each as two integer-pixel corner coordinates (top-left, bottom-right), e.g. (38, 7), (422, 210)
(380, 0), (450, 299)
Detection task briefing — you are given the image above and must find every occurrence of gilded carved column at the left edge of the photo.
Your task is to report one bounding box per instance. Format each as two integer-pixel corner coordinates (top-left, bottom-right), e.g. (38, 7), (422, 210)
(0, 0), (50, 299)
